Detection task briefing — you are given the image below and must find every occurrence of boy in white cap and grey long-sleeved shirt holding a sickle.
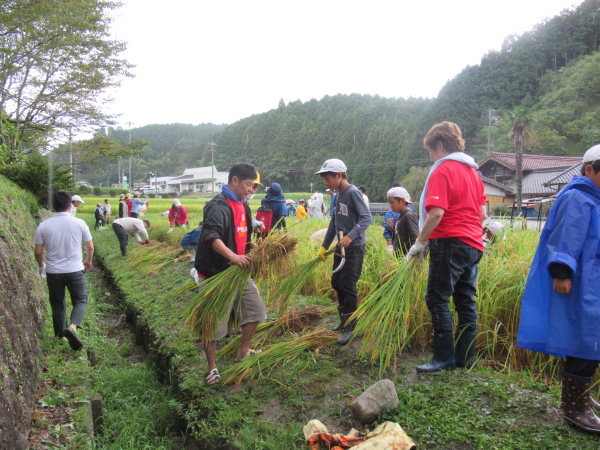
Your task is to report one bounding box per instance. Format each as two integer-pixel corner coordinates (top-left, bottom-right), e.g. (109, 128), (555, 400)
(315, 159), (373, 345)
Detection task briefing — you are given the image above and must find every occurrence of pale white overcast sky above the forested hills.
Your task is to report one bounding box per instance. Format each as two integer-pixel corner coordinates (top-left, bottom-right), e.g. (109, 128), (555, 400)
(103, 0), (581, 128)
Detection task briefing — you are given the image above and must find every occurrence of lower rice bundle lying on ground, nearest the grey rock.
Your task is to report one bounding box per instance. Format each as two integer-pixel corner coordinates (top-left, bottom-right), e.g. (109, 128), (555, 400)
(221, 328), (339, 384)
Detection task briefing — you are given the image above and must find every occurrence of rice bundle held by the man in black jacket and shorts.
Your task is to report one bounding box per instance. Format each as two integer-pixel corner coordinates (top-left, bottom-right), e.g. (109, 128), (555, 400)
(184, 233), (298, 344)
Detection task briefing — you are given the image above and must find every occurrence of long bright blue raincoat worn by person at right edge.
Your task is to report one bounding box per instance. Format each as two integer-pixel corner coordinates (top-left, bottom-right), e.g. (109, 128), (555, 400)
(517, 176), (600, 360)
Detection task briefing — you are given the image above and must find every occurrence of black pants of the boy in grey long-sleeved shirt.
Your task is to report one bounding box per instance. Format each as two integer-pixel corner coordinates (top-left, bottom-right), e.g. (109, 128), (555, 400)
(331, 244), (365, 314)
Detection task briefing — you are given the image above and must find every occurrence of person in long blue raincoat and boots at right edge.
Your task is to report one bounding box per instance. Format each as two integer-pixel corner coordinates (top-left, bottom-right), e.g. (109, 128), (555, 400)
(517, 145), (600, 434)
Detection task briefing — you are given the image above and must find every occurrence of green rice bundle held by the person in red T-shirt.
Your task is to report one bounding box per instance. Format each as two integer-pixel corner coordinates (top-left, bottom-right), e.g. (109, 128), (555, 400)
(351, 259), (421, 373)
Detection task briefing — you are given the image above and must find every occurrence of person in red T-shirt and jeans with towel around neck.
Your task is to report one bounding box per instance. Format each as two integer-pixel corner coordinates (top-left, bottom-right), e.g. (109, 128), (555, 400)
(407, 122), (486, 373)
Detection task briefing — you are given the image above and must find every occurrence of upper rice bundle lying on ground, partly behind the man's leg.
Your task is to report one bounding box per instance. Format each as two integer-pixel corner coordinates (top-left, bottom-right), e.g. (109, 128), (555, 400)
(217, 306), (323, 357)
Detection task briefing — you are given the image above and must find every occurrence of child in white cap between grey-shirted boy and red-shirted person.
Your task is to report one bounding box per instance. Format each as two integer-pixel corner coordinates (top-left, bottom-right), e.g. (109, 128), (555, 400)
(387, 187), (419, 256)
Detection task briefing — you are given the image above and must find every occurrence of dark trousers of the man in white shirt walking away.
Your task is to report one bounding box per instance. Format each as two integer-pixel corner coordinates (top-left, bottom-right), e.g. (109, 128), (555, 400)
(46, 270), (88, 337)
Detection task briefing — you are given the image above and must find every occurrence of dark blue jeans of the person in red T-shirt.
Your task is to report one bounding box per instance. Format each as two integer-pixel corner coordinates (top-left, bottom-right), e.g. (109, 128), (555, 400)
(425, 238), (483, 336)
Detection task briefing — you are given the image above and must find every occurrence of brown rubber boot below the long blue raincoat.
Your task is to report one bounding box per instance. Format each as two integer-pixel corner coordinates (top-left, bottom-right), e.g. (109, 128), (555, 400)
(560, 372), (600, 434)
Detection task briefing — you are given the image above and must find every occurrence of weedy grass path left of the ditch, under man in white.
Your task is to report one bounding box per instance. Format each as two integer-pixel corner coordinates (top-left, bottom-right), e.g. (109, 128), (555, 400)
(29, 266), (184, 450)
